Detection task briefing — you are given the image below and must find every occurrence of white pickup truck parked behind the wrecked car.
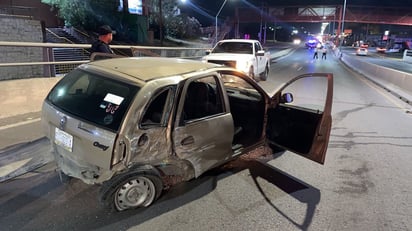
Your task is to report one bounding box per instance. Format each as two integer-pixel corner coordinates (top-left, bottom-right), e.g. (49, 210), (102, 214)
(202, 39), (270, 80)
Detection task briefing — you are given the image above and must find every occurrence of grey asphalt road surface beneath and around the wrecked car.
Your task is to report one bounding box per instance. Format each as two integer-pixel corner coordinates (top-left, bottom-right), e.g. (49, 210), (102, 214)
(0, 45), (412, 231)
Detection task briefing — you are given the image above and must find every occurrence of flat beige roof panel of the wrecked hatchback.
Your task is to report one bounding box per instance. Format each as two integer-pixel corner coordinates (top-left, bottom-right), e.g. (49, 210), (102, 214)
(87, 57), (219, 82)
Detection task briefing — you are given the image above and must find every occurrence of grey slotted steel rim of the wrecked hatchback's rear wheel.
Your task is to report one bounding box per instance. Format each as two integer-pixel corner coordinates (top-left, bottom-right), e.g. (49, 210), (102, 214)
(114, 176), (156, 211)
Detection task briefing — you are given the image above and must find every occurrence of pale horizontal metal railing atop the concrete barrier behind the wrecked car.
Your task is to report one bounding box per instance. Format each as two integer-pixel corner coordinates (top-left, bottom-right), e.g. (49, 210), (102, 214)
(0, 41), (209, 80)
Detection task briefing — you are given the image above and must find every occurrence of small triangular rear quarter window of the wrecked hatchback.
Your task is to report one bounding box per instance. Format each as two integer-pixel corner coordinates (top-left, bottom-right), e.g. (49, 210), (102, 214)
(141, 88), (172, 127)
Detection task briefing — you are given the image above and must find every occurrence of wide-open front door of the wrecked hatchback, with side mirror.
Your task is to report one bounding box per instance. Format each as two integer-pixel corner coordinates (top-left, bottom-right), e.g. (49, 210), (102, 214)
(266, 73), (333, 164)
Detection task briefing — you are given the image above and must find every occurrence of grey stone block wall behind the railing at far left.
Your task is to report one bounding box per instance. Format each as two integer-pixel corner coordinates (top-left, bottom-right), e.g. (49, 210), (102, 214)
(0, 16), (44, 81)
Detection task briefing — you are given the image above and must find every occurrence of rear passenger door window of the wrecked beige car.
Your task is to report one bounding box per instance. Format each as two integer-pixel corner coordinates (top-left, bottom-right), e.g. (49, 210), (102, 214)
(183, 76), (224, 121)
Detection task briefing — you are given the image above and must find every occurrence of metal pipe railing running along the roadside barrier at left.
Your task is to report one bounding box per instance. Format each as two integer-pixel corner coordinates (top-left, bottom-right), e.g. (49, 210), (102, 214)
(0, 41), (210, 81)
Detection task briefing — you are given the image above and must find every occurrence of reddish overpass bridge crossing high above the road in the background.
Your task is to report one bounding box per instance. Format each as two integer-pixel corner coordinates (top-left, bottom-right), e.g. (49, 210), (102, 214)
(235, 5), (412, 34)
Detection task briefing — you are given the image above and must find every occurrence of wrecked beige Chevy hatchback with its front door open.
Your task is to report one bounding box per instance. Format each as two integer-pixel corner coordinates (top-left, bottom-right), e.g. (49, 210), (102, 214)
(42, 58), (333, 211)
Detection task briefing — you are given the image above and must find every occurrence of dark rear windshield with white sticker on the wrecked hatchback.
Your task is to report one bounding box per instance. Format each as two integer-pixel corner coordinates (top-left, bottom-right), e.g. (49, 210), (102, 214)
(46, 69), (140, 131)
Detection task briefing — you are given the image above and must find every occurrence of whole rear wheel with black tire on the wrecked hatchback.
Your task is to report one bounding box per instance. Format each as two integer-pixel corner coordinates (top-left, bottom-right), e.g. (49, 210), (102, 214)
(100, 171), (163, 211)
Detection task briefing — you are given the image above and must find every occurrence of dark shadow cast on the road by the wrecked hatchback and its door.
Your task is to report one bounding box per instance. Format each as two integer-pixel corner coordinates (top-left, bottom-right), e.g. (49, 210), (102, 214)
(0, 153), (320, 230)
